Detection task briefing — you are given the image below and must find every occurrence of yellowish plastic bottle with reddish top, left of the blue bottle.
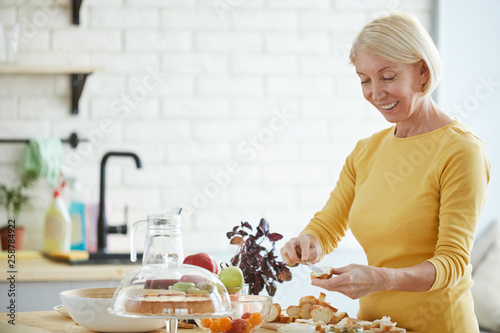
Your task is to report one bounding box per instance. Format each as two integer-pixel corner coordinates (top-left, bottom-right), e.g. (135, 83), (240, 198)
(44, 189), (71, 253)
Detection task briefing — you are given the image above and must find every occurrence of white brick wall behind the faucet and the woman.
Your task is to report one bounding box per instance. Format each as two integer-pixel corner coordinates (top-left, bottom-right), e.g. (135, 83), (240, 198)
(0, 0), (432, 260)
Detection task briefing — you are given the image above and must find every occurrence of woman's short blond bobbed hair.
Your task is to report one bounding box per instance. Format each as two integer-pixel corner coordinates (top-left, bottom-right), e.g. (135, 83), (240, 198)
(349, 12), (441, 96)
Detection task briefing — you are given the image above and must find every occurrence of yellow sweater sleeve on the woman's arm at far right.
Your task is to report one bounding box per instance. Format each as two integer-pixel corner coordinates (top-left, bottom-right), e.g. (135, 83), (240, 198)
(428, 128), (490, 290)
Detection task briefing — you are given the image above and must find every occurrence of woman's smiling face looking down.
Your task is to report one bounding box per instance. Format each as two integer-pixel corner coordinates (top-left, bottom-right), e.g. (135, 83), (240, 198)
(355, 52), (429, 123)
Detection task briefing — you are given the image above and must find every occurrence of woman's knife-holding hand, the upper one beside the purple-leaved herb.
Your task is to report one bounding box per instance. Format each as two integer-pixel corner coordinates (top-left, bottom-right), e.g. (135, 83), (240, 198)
(281, 235), (322, 265)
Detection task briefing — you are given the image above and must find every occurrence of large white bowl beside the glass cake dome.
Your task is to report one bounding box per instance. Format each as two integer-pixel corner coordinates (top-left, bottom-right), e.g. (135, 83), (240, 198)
(59, 288), (165, 332)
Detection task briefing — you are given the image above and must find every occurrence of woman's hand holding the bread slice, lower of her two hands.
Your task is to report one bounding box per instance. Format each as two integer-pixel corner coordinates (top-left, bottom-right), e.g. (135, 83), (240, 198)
(311, 264), (390, 299)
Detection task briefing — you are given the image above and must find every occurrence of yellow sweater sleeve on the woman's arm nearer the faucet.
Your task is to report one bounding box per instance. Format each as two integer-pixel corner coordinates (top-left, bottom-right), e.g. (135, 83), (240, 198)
(301, 139), (366, 255)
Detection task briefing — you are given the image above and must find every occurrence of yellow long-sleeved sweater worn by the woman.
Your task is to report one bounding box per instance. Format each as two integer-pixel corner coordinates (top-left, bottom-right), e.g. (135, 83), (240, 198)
(303, 120), (490, 333)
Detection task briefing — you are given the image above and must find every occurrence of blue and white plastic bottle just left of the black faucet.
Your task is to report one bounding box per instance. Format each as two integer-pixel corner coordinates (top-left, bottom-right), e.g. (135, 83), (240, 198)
(69, 178), (87, 250)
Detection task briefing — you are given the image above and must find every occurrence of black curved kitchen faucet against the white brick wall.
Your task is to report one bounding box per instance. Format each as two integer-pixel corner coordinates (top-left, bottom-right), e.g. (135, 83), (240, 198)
(97, 151), (142, 253)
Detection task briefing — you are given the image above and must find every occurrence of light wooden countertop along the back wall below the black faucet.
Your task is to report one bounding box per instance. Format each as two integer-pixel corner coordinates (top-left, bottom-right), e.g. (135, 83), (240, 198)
(0, 253), (141, 282)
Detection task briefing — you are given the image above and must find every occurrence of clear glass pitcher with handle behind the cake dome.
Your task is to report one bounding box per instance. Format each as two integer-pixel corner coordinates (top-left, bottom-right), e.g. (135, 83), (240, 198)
(130, 208), (184, 266)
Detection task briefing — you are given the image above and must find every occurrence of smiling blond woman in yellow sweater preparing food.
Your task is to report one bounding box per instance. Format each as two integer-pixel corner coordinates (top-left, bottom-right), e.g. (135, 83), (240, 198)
(281, 13), (490, 333)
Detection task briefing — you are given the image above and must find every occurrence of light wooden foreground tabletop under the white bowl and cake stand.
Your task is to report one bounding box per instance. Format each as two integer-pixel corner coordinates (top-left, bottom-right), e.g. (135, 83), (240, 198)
(0, 311), (276, 333)
